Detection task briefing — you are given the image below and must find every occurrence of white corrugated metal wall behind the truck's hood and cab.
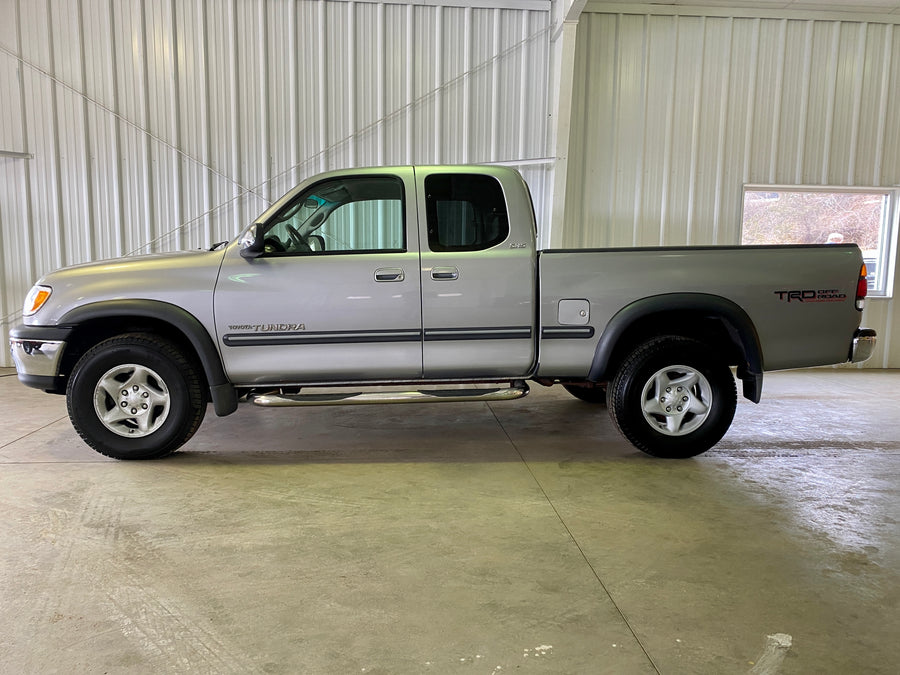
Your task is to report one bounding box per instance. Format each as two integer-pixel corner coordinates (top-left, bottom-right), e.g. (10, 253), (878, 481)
(0, 0), (551, 365)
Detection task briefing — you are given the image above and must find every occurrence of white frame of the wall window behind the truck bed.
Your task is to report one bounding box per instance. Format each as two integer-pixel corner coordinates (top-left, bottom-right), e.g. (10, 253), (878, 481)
(739, 183), (900, 298)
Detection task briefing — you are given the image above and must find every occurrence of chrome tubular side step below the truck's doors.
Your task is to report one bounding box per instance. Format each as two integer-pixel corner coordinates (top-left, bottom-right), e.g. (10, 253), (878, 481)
(250, 382), (529, 408)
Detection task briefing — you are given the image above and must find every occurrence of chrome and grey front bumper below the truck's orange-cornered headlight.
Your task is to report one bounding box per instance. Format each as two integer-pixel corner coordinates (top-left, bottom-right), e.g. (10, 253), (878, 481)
(9, 326), (71, 393)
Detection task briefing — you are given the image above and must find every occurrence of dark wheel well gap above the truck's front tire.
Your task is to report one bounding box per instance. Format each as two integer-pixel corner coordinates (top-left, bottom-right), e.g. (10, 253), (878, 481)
(58, 316), (209, 401)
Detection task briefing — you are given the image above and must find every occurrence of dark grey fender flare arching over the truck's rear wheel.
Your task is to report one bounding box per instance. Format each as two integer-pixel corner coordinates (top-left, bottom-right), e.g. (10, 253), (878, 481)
(588, 293), (764, 403)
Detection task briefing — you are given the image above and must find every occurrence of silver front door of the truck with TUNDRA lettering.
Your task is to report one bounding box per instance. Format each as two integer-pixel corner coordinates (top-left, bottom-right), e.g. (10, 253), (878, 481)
(215, 169), (422, 385)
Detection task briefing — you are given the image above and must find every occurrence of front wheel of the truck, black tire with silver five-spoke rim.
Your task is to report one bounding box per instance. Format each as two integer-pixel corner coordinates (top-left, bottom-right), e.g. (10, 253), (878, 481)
(66, 333), (206, 459)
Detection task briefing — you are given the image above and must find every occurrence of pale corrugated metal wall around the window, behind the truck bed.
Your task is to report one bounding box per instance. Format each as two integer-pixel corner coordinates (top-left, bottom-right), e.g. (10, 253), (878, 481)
(563, 13), (900, 367)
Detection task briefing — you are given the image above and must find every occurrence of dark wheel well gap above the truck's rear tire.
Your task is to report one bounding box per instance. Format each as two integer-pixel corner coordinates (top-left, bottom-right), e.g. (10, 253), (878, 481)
(604, 310), (747, 379)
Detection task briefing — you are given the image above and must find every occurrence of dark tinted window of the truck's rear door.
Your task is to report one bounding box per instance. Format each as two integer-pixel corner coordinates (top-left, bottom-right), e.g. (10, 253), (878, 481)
(425, 174), (509, 251)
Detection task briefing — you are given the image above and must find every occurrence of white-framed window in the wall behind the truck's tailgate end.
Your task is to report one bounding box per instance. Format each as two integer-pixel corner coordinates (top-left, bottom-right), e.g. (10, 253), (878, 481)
(741, 185), (896, 295)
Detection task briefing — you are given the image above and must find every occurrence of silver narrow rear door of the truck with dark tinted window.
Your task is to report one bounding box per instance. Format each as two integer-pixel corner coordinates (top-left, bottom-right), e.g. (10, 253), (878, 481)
(416, 167), (536, 379)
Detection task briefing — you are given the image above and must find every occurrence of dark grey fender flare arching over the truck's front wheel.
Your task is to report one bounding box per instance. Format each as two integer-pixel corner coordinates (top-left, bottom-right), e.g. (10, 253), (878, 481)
(58, 299), (237, 417)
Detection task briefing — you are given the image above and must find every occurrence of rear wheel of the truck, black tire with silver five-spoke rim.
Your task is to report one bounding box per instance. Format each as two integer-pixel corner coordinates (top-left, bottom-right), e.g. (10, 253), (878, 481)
(609, 336), (737, 458)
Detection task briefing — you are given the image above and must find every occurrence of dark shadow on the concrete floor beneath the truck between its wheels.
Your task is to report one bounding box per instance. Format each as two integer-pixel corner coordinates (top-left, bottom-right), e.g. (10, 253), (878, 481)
(164, 397), (646, 464)
